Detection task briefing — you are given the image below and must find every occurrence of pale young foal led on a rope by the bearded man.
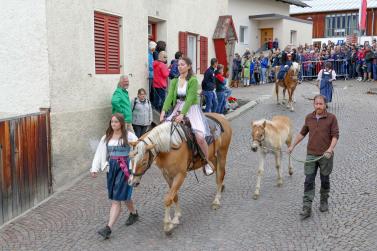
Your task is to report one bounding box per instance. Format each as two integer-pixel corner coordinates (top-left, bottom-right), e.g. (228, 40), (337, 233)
(251, 116), (293, 199)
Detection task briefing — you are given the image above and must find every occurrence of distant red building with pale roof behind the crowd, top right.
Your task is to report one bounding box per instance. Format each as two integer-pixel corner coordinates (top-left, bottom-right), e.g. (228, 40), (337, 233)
(290, 0), (377, 43)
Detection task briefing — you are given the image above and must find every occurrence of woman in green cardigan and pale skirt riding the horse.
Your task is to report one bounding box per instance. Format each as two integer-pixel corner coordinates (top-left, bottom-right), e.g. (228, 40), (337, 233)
(160, 57), (214, 175)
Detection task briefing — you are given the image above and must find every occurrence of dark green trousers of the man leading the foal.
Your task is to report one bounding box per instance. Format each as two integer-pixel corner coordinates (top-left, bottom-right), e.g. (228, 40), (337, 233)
(303, 154), (334, 208)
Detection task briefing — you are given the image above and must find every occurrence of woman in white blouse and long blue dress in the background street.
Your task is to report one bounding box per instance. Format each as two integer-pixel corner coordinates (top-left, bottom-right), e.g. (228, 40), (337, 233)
(317, 62), (336, 104)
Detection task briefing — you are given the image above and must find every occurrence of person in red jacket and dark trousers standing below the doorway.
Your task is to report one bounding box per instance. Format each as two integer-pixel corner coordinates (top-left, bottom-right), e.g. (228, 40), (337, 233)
(153, 51), (169, 112)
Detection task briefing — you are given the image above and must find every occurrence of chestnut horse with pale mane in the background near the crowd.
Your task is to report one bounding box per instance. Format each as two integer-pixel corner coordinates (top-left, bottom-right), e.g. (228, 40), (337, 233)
(275, 62), (300, 112)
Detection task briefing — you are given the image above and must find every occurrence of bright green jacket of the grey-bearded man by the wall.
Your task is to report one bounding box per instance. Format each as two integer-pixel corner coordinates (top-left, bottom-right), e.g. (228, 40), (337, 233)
(111, 87), (132, 124)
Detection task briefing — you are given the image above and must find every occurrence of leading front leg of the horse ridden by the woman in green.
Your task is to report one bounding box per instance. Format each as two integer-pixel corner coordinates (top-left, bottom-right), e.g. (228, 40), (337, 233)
(164, 173), (186, 235)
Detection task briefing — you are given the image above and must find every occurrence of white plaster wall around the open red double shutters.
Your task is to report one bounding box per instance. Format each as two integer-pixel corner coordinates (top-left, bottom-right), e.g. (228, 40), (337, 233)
(144, 0), (228, 80)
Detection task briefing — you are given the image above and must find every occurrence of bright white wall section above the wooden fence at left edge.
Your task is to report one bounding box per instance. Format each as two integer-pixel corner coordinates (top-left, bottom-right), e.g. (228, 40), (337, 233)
(0, 0), (50, 114)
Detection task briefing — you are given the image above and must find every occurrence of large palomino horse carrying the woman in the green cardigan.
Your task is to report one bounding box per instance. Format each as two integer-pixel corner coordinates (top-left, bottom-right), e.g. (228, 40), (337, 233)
(128, 113), (232, 234)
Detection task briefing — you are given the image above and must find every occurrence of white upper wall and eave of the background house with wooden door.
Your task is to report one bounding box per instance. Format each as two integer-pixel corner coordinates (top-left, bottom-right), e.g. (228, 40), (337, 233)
(228, 0), (289, 53)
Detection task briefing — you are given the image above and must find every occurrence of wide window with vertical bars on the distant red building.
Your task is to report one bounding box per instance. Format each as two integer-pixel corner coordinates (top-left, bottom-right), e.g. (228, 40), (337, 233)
(325, 13), (359, 37)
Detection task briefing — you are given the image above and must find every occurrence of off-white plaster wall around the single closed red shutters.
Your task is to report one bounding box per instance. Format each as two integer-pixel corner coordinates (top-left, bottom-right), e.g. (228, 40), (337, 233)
(47, 0), (148, 187)
